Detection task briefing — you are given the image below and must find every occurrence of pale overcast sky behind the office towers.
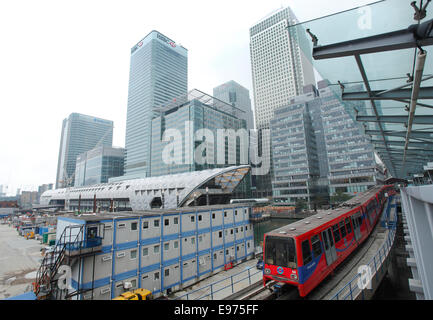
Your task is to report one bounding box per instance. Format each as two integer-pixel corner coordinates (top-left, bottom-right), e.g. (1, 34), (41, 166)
(0, 0), (374, 194)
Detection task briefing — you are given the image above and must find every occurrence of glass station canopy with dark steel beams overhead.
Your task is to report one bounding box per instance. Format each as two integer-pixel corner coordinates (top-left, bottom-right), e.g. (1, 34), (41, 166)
(288, 0), (433, 178)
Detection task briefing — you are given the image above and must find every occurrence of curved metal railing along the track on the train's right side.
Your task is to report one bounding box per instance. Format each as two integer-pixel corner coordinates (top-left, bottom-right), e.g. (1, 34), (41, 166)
(330, 197), (397, 300)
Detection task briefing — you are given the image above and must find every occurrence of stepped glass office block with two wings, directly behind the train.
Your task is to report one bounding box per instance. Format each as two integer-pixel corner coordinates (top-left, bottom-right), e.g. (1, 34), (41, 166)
(270, 80), (383, 209)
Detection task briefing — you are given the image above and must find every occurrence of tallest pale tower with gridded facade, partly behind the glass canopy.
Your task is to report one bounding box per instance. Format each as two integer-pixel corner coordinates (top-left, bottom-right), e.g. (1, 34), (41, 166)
(250, 8), (315, 196)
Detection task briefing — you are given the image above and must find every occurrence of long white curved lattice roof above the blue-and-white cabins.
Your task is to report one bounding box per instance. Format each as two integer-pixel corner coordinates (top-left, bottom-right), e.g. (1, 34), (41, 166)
(41, 165), (250, 210)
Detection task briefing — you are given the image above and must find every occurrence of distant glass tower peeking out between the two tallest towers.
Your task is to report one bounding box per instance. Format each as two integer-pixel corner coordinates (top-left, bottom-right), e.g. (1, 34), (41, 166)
(213, 80), (254, 130)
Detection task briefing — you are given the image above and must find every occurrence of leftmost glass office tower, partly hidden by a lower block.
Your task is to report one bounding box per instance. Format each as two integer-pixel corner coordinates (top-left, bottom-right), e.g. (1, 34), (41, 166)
(56, 113), (113, 189)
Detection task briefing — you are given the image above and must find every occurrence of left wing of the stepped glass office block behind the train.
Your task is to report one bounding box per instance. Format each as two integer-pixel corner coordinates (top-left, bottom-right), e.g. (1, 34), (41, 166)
(270, 86), (322, 208)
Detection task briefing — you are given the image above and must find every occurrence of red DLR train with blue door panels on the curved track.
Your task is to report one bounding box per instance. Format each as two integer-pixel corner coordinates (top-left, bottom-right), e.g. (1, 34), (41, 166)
(263, 185), (395, 297)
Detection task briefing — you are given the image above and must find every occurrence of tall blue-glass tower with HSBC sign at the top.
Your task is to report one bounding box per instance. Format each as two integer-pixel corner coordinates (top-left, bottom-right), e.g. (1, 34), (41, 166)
(121, 30), (188, 179)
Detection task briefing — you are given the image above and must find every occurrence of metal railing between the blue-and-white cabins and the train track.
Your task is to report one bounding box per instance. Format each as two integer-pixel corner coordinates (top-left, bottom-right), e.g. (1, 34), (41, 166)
(174, 266), (263, 300)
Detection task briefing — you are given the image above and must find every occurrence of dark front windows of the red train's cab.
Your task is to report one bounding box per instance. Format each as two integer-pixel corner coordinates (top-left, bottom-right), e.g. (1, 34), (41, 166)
(265, 236), (297, 269)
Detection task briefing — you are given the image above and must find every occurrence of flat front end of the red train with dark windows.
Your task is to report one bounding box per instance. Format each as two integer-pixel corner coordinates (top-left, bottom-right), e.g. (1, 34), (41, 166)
(263, 235), (298, 286)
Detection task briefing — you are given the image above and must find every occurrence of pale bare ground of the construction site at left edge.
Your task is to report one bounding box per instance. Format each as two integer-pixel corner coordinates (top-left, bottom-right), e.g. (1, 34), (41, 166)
(0, 225), (44, 300)
